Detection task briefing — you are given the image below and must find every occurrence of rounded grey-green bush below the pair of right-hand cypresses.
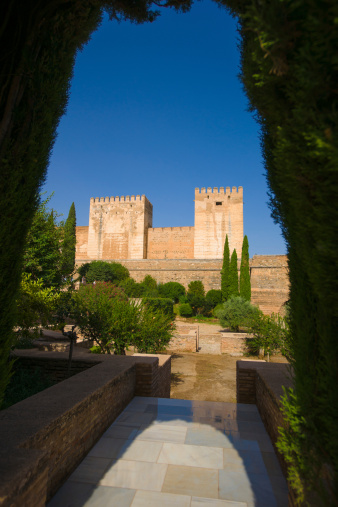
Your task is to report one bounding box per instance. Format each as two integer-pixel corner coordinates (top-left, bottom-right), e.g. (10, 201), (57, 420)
(217, 296), (259, 331)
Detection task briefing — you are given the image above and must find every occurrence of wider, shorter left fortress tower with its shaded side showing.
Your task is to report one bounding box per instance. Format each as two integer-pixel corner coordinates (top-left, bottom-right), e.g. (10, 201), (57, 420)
(87, 195), (153, 260)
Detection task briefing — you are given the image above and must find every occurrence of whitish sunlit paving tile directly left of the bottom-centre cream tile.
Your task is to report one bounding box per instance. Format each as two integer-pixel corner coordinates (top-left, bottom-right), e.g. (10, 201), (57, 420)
(100, 459), (167, 491)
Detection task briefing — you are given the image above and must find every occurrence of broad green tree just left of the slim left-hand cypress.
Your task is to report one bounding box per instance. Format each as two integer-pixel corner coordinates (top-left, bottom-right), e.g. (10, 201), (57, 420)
(23, 196), (63, 287)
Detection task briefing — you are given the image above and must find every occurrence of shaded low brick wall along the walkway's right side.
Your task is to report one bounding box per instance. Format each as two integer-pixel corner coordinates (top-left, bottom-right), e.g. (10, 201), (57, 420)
(236, 360), (294, 505)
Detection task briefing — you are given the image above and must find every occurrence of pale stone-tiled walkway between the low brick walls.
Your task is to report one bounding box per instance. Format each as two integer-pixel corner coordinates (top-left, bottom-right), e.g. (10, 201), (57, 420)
(48, 397), (288, 507)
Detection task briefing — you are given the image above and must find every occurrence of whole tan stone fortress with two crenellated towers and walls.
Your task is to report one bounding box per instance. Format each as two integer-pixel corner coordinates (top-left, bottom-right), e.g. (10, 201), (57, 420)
(76, 187), (289, 313)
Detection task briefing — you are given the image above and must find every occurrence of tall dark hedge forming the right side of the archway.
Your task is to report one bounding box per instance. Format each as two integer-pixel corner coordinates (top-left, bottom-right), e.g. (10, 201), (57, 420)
(228, 0), (338, 505)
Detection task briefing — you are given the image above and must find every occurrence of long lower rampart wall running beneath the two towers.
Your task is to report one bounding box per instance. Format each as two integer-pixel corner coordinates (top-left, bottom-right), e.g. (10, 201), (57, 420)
(77, 255), (289, 314)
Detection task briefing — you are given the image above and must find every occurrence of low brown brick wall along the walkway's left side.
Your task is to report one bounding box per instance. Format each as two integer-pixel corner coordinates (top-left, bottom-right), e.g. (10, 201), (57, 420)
(0, 351), (171, 507)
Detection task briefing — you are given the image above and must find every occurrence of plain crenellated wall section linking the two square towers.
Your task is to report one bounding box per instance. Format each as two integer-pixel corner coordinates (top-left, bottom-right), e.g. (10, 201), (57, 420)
(147, 227), (194, 259)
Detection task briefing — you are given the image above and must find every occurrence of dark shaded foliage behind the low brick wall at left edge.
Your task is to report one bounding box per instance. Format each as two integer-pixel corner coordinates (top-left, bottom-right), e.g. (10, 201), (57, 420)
(1, 364), (54, 410)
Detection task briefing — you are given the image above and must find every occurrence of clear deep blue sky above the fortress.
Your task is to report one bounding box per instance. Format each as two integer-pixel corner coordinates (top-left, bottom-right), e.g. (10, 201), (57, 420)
(43, 0), (285, 256)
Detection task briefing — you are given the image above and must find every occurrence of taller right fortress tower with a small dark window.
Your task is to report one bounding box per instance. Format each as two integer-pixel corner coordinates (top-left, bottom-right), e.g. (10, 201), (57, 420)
(194, 187), (243, 259)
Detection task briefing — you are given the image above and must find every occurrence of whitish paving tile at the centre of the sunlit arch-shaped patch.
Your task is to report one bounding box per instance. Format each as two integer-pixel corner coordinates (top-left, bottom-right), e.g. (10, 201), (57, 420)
(157, 443), (223, 469)
